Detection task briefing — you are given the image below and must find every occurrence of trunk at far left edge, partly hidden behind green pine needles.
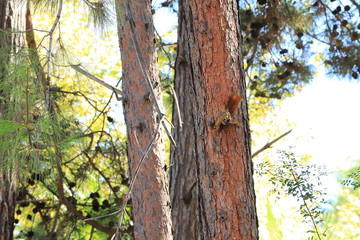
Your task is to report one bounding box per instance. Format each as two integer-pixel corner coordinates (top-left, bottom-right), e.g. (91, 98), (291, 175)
(0, 0), (26, 240)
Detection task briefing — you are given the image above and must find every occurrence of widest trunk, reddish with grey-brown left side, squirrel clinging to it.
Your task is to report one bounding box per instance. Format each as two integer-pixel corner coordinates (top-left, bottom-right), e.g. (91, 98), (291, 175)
(170, 0), (258, 240)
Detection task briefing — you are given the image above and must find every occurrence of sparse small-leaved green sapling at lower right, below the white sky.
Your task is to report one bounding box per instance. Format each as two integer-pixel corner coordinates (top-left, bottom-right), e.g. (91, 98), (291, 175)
(255, 151), (327, 239)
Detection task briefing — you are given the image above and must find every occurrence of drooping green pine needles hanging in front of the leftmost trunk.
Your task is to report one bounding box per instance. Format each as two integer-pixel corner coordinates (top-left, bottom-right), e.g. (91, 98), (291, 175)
(0, 45), (45, 178)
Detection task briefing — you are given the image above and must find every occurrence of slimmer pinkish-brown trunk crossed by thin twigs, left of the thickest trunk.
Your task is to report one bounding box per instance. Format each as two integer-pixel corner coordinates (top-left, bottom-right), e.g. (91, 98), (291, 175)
(117, 0), (171, 239)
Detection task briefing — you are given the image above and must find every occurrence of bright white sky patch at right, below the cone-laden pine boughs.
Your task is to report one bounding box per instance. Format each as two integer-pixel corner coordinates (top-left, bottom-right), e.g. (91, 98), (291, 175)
(280, 73), (360, 171)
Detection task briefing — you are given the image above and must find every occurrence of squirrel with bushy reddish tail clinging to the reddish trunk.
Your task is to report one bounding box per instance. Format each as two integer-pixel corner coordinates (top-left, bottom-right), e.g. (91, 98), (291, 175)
(213, 94), (243, 130)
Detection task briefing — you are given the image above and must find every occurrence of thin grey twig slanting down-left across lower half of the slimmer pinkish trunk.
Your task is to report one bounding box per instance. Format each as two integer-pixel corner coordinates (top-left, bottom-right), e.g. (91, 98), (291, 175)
(111, 116), (164, 239)
